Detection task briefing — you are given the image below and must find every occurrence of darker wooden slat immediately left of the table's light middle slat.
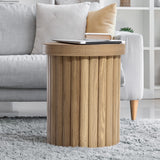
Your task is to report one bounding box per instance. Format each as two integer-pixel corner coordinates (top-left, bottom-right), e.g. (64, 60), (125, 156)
(71, 57), (80, 146)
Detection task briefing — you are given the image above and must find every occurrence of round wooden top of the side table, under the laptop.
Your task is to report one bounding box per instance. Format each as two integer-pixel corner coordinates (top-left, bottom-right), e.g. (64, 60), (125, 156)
(43, 42), (125, 57)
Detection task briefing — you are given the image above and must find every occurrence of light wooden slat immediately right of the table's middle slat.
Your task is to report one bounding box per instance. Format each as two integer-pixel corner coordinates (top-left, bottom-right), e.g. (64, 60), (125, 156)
(89, 57), (98, 147)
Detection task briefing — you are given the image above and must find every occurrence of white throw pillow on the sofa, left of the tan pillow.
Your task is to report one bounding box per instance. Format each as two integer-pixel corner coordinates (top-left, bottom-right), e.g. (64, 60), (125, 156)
(32, 2), (90, 54)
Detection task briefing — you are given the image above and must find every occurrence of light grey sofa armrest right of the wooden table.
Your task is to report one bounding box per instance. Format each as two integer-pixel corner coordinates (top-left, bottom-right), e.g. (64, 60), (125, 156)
(115, 32), (144, 100)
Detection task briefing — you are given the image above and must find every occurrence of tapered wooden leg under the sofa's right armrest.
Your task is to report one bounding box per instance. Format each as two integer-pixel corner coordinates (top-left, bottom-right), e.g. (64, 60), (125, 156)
(130, 100), (138, 120)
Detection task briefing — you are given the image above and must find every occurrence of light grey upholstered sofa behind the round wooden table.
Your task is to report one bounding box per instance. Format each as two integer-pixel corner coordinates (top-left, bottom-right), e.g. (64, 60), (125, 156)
(0, 4), (143, 119)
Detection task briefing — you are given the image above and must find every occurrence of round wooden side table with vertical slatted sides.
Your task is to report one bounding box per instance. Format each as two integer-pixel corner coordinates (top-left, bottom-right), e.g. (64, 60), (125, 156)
(44, 43), (125, 147)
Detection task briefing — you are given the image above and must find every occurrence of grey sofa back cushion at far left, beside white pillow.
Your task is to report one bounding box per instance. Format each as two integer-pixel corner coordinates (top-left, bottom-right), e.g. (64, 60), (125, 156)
(0, 4), (36, 55)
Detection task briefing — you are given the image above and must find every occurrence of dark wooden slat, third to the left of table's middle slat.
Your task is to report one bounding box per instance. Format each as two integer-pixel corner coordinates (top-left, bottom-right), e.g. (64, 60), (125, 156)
(53, 57), (63, 145)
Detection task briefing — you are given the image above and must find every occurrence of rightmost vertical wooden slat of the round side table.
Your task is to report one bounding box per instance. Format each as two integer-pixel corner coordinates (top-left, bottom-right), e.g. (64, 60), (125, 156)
(112, 56), (119, 144)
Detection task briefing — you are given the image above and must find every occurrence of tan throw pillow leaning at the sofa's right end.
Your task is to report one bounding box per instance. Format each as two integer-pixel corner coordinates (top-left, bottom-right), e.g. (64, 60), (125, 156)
(86, 3), (117, 36)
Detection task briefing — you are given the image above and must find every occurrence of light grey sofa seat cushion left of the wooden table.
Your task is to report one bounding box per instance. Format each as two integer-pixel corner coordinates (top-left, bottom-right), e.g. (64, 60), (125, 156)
(0, 55), (47, 88)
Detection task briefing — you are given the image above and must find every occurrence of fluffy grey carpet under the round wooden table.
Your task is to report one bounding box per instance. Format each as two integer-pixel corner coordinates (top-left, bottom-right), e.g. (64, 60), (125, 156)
(0, 118), (160, 160)
